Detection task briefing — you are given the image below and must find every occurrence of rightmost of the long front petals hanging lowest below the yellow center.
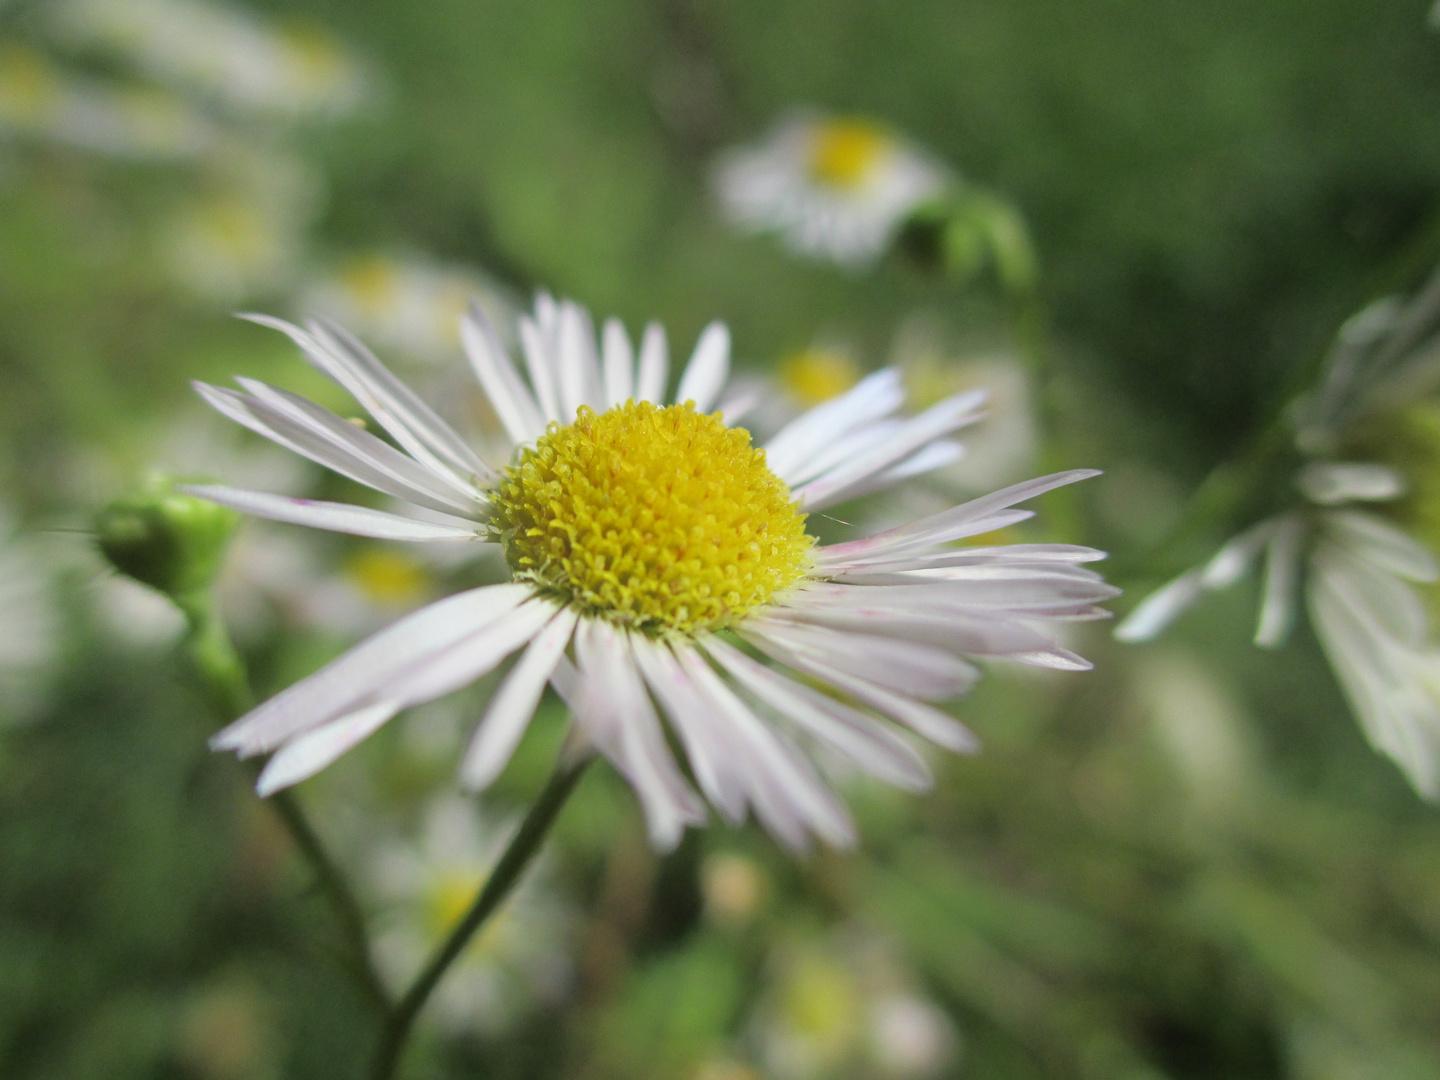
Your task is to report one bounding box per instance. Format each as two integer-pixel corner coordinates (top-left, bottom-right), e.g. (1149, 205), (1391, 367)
(675, 648), (855, 848)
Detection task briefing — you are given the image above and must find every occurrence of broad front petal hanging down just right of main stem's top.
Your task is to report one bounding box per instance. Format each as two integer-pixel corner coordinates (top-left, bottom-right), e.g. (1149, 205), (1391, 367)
(575, 619), (706, 851)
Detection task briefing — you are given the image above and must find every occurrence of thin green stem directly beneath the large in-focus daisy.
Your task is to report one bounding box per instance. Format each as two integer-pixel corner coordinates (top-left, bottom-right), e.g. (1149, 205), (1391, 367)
(370, 750), (592, 1080)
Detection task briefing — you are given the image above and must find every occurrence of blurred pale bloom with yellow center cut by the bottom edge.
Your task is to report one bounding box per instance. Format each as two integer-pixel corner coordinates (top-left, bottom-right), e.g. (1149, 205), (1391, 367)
(753, 927), (958, 1080)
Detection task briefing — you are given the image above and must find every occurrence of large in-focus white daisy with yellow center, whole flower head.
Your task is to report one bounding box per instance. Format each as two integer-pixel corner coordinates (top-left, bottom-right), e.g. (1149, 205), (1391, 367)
(189, 295), (1116, 848)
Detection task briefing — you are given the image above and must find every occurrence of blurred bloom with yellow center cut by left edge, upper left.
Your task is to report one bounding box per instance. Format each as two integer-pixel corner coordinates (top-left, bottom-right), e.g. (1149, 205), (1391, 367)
(0, 45), (216, 160)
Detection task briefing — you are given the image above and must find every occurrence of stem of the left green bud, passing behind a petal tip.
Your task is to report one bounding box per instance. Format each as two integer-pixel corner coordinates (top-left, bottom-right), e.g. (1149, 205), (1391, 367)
(176, 592), (390, 1015)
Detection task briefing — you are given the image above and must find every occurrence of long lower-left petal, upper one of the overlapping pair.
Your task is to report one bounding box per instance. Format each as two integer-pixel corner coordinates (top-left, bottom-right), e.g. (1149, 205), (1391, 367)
(210, 583), (533, 757)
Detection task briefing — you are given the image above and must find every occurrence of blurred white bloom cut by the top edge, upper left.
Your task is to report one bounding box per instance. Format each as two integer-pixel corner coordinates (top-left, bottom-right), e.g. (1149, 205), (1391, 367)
(52, 0), (369, 118)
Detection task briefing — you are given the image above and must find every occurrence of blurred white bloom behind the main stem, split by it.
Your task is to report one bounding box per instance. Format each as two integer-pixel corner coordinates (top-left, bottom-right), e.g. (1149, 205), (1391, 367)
(370, 796), (573, 1035)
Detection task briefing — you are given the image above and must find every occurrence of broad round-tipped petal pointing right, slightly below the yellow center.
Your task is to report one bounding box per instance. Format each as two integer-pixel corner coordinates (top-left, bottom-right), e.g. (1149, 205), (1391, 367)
(740, 618), (979, 698)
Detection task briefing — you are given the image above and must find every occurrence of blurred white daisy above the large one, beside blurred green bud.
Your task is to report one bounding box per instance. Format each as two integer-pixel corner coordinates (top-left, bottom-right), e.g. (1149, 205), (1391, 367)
(714, 114), (953, 268)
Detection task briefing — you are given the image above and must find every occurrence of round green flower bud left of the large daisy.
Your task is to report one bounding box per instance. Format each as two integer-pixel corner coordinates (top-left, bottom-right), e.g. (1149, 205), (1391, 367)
(95, 472), (240, 603)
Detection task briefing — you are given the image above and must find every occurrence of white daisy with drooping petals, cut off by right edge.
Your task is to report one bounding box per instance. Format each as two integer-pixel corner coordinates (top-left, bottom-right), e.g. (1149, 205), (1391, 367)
(1116, 272), (1440, 799)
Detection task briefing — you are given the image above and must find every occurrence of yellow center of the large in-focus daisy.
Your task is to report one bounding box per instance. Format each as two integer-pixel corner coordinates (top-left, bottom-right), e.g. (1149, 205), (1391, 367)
(491, 402), (814, 634)
